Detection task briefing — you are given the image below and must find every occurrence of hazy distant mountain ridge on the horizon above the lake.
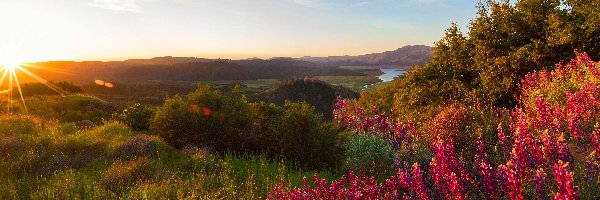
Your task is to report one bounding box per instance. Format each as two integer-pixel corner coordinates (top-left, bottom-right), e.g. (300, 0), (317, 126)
(298, 45), (433, 66)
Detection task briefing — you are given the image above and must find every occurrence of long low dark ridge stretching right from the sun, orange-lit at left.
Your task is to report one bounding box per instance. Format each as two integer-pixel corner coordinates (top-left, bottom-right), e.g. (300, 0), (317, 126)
(20, 59), (362, 83)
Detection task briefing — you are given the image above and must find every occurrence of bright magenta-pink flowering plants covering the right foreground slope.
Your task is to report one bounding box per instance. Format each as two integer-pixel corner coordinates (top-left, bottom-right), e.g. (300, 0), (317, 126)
(284, 53), (600, 199)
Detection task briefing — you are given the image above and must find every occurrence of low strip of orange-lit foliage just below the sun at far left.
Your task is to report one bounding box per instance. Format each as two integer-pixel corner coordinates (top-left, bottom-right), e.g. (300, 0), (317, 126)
(13, 81), (83, 96)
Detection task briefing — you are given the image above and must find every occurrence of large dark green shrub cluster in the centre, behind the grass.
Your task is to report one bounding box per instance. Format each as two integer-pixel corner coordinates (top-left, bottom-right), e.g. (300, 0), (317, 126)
(150, 85), (340, 168)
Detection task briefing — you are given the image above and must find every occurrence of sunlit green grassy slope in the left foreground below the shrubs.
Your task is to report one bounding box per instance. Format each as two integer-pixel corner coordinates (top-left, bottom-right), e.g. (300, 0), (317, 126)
(0, 115), (339, 199)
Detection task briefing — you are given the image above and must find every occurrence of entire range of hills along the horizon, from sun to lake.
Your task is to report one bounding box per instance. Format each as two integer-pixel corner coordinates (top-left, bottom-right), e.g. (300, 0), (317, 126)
(19, 45), (432, 84)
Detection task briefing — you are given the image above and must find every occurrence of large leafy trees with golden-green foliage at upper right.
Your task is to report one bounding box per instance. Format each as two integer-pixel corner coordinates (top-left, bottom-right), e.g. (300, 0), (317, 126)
(360, 0), (600, 125)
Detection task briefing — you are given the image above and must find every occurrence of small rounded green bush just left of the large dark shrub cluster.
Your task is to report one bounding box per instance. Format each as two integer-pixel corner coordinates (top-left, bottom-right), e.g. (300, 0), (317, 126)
(113, 103), (156, 131)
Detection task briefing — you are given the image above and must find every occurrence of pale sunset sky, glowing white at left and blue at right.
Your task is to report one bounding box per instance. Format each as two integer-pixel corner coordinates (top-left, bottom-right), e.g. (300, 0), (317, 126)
(0, 0), (478, 61)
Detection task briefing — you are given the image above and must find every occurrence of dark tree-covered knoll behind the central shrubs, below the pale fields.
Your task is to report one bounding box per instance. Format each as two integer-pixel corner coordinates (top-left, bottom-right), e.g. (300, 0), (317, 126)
(254, 78), (360, 120)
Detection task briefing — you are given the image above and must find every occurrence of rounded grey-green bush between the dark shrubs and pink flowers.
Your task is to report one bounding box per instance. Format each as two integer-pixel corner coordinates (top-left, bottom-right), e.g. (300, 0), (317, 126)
(345, 133), (394, 176)
